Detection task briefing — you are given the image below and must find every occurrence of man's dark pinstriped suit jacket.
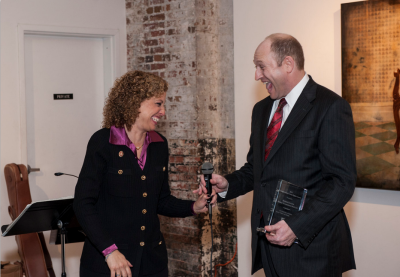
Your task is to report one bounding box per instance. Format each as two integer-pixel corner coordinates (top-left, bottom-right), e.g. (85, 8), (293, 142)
(219, 77), (357, 277)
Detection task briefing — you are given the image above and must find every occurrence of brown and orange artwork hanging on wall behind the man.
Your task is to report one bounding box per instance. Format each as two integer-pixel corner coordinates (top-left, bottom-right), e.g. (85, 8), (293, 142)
(341, 0), (400, 190)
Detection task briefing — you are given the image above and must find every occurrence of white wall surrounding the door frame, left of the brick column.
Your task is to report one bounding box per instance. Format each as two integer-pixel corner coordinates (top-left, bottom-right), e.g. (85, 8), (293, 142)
(0, 0), (127, 276)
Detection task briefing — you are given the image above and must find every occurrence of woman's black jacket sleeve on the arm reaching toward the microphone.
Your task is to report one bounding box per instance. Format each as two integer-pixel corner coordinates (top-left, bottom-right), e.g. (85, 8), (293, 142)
(157, 139), (193, 217)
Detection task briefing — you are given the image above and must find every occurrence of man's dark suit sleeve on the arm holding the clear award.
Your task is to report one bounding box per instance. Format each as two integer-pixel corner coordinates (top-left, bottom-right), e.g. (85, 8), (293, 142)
(285, 98), (357, 248)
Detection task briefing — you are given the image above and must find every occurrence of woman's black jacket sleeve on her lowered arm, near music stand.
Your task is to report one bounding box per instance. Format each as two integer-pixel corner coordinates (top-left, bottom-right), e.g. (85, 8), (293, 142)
(73, 133), (115, 252)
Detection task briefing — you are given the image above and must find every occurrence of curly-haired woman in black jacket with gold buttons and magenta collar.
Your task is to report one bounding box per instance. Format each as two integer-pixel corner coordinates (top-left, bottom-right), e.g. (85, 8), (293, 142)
(74, 71), (216, 277)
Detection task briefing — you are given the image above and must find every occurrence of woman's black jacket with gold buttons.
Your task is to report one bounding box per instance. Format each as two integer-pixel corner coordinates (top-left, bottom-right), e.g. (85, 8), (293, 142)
(74, 129), (193, 276)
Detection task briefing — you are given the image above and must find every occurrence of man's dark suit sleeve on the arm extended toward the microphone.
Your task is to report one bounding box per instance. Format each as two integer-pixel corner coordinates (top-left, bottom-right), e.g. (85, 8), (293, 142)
(218, 105), (257, 202)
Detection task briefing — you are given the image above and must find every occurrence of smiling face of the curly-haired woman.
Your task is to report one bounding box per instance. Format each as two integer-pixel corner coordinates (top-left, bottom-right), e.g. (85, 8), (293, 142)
(132, 92), (167, 132)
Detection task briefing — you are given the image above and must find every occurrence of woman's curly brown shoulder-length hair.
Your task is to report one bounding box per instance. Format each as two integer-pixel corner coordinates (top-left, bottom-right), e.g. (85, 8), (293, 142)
(102, 71), (168, 131)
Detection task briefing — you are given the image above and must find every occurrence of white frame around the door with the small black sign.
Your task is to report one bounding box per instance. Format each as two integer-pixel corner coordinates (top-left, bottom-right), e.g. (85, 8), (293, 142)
(18, 24), (121, 164)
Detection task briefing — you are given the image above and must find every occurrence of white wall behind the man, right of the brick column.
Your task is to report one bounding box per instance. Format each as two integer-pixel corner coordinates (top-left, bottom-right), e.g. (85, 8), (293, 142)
(234, 0), (400, 277)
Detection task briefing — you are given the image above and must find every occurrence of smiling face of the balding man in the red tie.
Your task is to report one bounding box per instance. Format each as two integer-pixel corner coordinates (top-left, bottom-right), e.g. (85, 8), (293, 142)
(254, 39), (290, 99)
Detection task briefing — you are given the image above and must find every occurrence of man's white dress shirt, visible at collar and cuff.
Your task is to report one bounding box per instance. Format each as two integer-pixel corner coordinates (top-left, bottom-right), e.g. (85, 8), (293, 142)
(218, 73), (310, 198)
